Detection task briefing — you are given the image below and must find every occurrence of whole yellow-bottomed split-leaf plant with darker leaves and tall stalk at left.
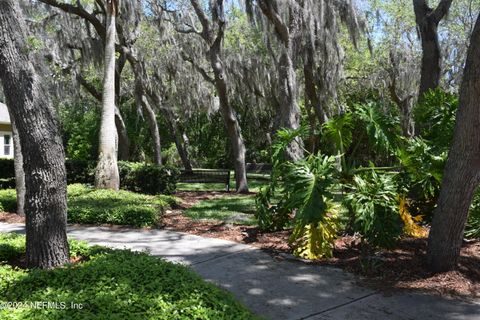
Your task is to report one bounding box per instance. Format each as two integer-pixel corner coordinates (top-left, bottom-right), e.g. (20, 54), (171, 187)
(256, 130), (338, 259)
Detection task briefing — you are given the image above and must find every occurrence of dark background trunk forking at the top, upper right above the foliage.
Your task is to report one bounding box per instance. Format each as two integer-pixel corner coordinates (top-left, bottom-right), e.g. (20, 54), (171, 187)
(413, 0), (452, 101)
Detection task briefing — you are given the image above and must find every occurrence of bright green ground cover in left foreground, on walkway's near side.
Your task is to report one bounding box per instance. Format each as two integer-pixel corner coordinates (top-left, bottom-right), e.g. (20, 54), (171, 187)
(0, 234), (256, 320)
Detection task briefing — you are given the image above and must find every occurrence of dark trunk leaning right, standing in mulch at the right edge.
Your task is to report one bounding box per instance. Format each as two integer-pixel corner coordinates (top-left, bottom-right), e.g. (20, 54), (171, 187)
(427, 11), (480, 272)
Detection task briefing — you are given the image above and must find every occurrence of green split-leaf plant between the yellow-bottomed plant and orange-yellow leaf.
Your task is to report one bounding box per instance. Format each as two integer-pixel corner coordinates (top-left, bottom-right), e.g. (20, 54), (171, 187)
(345, 170), (403, 248)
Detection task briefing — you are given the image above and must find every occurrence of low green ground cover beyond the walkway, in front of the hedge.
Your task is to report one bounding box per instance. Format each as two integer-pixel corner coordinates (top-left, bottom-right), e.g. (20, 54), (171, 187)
(0, 184), (176, 227)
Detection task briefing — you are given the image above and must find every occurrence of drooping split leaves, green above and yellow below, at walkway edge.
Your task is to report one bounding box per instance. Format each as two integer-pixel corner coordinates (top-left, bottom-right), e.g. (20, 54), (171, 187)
(283, 154), (339, 259)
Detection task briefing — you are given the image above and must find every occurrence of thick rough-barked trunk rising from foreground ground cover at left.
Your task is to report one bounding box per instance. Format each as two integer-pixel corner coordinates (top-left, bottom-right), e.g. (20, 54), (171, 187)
(0, 0), (69, 268)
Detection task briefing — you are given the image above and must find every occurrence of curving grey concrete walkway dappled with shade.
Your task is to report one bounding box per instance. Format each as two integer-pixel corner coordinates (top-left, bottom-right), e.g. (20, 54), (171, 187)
(0, 223), (480, 320)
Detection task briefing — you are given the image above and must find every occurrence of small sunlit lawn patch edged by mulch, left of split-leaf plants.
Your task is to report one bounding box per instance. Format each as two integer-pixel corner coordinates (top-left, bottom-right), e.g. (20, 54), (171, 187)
(183, 195), (256, 225)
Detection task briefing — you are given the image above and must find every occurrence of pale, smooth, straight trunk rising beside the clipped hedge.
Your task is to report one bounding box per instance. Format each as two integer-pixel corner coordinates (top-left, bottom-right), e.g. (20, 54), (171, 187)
(95, 0), (120, 190)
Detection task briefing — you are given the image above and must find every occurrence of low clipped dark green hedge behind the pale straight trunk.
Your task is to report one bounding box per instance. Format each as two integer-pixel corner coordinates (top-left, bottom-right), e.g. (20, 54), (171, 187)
(0, 159), (180, 194)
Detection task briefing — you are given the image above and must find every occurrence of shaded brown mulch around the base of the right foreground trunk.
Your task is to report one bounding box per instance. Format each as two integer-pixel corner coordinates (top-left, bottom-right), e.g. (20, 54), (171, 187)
(322, 236), (480, 298)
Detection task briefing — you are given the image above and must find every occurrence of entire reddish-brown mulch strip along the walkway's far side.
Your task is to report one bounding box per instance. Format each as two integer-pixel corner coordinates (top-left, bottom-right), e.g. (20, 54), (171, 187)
(0, 191), (480, 298)
